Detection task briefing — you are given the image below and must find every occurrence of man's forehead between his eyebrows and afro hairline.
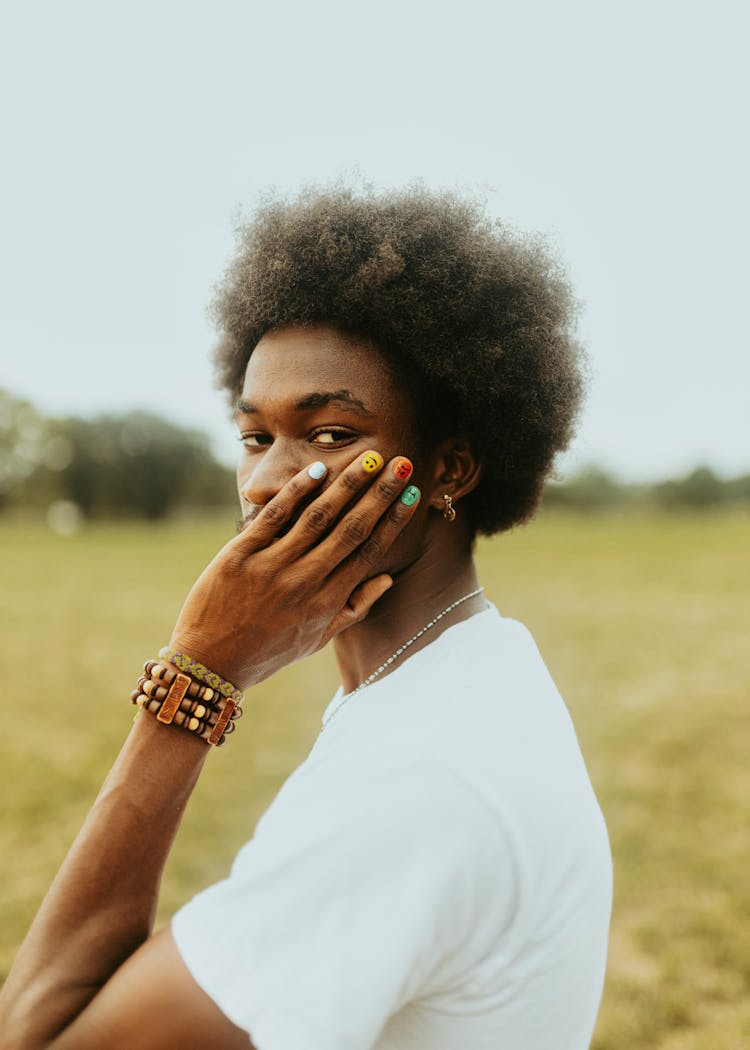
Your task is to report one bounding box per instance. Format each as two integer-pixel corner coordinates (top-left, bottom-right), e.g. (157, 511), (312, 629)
(242, 326), (407, 411)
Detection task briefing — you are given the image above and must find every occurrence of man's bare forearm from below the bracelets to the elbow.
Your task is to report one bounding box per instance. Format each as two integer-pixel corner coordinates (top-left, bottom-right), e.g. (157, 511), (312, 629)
(0, 715), (210, 1047)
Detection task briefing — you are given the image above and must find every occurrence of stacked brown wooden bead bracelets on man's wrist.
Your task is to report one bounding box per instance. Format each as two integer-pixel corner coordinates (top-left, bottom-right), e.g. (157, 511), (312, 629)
(130, 654), (243, 748)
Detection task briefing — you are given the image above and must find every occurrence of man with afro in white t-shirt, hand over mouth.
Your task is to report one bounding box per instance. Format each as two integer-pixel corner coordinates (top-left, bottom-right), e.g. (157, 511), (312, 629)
(0, 191), (611, 1050)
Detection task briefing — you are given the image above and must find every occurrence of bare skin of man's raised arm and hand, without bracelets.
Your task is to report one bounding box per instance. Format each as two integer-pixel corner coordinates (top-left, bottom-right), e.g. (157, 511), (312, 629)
(0, 454), (418, 1050)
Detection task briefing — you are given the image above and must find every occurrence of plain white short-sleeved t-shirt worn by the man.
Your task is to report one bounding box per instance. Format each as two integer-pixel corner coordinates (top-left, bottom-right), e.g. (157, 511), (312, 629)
(172, 607), (611, 1050)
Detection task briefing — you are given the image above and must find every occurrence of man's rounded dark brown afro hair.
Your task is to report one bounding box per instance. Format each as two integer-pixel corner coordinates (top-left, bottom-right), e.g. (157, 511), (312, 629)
(212, 187), (583, 534)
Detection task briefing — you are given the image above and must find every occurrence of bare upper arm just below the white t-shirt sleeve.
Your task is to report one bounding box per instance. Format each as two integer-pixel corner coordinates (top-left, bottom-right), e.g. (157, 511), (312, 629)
(50, 928), (253, 1050)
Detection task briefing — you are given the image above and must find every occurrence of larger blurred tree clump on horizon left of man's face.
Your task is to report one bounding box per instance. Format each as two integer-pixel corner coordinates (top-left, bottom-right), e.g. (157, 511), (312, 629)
(0, 391), (236, 521)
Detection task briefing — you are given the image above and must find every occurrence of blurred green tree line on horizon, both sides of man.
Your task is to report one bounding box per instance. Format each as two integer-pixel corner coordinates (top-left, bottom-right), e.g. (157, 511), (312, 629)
(0, 391), (750, 520)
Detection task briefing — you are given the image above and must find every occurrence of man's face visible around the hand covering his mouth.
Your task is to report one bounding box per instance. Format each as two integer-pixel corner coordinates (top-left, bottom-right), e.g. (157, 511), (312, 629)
(236, 326), (428, 571)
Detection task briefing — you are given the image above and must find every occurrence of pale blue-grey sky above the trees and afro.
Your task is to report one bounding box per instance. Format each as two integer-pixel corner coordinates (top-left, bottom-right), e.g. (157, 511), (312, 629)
(0, 0), (750, 480)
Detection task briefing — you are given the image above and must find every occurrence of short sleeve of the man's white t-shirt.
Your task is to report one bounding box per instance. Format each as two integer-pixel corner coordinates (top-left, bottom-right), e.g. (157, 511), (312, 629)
(172, 762), (517, 1050)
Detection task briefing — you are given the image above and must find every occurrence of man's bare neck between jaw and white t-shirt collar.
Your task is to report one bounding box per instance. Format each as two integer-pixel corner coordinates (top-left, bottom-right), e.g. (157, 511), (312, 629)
(334, 552), (478, 693)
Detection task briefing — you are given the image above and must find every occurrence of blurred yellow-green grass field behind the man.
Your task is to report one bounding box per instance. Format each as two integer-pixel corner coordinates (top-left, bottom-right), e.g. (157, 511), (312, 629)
(0, 513), (750, 1050)
